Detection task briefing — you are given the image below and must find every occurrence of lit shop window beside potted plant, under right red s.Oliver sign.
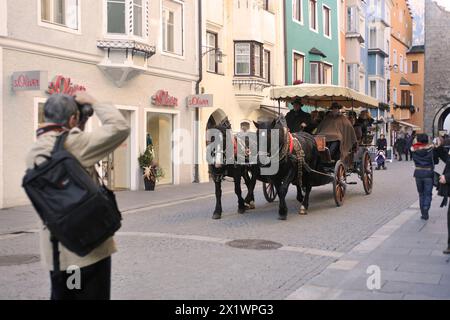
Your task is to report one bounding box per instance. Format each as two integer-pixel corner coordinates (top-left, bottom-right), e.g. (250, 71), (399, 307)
(146, 112), (173, 184)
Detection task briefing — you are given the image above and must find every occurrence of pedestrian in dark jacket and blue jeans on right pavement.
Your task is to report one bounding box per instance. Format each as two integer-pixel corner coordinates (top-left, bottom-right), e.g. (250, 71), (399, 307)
(412, 134), (439, 221)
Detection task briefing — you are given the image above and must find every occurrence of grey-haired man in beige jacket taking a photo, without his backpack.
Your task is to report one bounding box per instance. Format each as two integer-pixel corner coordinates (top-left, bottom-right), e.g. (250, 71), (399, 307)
(26, 92), (130, 300)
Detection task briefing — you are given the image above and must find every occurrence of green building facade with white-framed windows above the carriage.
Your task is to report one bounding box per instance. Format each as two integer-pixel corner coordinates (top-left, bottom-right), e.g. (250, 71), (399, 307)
(284, 0), (340, 85)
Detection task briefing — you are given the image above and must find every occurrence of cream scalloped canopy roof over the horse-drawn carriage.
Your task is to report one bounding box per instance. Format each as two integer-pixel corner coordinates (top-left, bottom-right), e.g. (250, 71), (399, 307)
(270, 83), (379, 109)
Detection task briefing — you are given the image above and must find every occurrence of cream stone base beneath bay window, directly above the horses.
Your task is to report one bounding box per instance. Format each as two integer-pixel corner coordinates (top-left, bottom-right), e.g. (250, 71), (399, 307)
(233, 77), (271, 110)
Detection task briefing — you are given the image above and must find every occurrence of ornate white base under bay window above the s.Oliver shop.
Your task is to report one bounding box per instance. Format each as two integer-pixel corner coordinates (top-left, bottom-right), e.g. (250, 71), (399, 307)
(97, 39), (156, 88)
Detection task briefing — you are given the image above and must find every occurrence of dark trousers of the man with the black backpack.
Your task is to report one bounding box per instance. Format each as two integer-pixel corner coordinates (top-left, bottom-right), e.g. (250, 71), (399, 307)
(50, 257), (111, 300)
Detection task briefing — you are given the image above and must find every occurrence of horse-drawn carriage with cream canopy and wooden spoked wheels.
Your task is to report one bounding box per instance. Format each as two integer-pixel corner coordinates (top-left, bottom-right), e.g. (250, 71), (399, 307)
(263, 84), (378, 207)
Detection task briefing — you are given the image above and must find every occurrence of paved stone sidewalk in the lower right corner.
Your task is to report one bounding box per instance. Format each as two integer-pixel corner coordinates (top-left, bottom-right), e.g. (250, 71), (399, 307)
(287, 197), (450, 300)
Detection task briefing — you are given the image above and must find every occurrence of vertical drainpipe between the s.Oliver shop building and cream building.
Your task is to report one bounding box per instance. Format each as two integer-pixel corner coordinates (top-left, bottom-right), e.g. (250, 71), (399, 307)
(194, 0), (203, 183)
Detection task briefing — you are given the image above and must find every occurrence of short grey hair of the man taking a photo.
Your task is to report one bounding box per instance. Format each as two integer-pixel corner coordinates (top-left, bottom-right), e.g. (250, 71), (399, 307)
(44, 94), (78, 125)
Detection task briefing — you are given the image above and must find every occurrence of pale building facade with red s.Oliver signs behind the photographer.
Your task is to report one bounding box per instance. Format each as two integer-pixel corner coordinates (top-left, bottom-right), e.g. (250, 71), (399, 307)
(0, 0), (199, 208)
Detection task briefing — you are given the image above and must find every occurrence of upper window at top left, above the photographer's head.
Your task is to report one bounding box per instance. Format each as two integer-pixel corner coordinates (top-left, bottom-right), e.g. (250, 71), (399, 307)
(41, 0), (79, 30)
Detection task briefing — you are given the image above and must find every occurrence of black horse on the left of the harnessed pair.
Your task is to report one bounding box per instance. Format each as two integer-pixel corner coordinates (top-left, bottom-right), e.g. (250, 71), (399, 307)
(208, 118), (257, 220)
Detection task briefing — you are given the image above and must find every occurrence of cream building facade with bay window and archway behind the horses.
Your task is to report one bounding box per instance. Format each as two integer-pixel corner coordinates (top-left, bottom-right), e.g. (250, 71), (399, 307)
(198, 0), (285, 182)
